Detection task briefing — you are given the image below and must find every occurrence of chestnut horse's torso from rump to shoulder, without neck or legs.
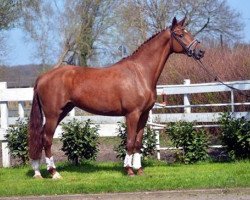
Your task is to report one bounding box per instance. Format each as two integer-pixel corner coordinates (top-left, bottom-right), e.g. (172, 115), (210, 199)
(34, 64), (152, 115)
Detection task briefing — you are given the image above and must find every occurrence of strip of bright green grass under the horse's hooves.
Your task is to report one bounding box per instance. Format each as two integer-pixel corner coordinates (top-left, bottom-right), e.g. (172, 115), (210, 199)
(0, 161), (250, 196)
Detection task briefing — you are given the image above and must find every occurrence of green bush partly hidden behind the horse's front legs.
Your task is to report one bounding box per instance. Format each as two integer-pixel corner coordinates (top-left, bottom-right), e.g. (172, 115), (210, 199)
(114, 122), (156, 160)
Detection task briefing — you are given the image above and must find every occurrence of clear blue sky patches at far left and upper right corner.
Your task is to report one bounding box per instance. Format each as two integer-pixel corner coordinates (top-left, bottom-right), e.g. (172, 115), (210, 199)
(6, 0), (250, 66)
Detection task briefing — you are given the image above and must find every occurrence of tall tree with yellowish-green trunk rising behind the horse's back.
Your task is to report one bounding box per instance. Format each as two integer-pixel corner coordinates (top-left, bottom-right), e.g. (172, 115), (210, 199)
(59, 0), (117, 66)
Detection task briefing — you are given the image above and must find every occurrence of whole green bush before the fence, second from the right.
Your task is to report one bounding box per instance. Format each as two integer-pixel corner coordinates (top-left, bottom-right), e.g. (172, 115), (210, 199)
(167, 121), (208, 164)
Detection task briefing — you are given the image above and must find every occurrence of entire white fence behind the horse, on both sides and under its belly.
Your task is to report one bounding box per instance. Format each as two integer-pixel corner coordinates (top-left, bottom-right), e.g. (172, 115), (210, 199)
(0, 79), (250, 167)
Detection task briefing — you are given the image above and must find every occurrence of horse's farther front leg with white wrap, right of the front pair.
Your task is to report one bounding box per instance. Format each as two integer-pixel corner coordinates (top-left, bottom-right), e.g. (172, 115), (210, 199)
(133, 112), (149, 175)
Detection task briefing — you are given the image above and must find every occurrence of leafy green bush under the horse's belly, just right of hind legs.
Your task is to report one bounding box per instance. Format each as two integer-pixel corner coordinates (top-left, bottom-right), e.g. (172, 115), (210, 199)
(61, 119), (99, 165)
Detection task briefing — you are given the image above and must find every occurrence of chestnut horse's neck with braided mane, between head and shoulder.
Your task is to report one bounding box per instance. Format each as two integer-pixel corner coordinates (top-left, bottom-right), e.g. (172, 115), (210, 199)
(128, 30), (171, 88)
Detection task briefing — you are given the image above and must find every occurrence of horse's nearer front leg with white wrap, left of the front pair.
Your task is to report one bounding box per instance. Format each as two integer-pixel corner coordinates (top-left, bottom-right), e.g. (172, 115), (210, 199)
(124, 112), (140, 176)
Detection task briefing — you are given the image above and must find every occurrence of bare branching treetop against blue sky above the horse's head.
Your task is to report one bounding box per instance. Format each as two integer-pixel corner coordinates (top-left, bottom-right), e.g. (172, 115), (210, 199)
(173, 0), (244, 40)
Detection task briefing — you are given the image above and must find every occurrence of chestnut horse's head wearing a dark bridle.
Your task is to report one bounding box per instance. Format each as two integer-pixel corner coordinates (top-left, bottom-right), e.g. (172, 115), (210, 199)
(170, 18), (205, 60)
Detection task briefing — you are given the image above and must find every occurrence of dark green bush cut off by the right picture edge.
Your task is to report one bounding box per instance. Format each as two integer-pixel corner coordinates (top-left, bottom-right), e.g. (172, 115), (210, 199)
(219, 113), (250, 160)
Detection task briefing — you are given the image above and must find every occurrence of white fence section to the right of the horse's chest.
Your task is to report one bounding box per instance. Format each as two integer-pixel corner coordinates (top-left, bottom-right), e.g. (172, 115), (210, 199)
(152, 79), (250, 159)
